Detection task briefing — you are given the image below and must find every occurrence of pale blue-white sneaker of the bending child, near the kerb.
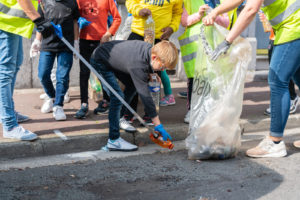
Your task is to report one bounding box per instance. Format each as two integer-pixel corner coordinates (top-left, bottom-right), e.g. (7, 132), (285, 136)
(106, 137), (138, 151)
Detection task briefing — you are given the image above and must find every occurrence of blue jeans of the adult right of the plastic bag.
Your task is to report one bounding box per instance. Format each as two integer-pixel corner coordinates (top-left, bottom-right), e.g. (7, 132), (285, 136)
(268, 39), (300, 137)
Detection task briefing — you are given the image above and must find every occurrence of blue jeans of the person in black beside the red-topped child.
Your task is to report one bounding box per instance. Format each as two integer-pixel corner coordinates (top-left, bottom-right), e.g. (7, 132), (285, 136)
(38, 51), (73, 106)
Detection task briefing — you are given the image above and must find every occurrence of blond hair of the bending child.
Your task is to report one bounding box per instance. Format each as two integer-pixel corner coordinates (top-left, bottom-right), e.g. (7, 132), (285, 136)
(152, 40), (178, 69)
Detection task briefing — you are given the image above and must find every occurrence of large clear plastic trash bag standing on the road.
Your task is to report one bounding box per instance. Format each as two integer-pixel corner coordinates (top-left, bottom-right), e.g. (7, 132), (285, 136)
(185, 24), (251, 160)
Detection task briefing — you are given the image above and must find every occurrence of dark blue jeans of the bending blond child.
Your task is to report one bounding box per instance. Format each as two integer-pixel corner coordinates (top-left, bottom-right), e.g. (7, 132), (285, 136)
(91, 59), (136, 140)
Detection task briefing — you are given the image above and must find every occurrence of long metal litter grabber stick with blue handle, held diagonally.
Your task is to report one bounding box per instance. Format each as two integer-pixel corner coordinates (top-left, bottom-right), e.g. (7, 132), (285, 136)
(51, 22), (165, 141)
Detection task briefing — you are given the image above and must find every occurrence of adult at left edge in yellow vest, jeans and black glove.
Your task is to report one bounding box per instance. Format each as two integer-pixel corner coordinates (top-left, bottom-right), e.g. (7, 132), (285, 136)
(0, 0), (54, 141)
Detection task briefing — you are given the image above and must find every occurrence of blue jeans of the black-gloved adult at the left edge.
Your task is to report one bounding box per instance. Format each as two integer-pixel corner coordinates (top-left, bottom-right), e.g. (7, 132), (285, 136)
(0, 30), (23, 131)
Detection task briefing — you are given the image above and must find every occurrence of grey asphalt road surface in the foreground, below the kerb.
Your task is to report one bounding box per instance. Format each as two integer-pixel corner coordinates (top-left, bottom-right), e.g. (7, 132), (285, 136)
(0, 130), (300, 200)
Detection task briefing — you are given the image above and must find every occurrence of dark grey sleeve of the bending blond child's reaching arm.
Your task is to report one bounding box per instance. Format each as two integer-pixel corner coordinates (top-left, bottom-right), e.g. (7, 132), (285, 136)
(129, 68), (157, 118)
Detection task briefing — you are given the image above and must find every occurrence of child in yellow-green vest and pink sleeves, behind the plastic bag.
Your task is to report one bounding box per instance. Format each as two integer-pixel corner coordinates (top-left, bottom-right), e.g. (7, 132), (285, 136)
(178, 0), (229, 123)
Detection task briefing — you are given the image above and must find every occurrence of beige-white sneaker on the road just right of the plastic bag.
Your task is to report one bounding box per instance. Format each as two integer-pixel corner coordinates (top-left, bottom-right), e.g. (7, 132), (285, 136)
(246, 136), (287, 158)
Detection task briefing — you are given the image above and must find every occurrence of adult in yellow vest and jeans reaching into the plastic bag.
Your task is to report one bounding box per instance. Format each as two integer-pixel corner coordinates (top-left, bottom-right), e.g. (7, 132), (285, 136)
(203, 0), (300, 157)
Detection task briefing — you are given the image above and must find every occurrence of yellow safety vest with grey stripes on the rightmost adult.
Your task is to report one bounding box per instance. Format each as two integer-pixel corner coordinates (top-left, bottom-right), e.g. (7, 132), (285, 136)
(262, 0), (300, 45)
